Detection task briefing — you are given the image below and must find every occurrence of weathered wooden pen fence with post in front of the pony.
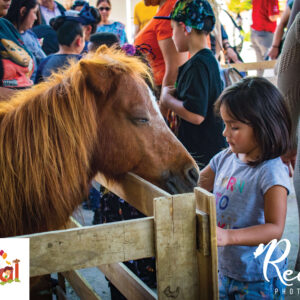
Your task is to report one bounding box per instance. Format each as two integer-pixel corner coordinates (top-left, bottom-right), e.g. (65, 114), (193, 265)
(26, 174), (218, 300)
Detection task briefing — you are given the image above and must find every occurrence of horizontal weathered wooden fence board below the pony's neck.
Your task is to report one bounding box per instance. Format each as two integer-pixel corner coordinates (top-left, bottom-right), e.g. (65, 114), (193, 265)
(28, 217), (154, 276)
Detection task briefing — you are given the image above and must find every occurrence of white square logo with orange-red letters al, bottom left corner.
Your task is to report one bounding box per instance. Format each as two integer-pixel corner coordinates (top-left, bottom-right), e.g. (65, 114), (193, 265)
(0, 238), (29, 300)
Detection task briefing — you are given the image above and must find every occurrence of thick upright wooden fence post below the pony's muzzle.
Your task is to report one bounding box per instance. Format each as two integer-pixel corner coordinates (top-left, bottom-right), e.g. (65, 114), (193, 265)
(154, 194), (200, 300)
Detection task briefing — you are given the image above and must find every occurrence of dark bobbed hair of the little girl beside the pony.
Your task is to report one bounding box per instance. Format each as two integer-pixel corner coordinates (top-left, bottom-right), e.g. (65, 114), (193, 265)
(215, 77), (291, 166)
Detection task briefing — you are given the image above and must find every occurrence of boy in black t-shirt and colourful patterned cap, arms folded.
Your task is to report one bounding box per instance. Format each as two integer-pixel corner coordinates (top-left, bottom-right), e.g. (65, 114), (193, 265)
(160, 0), (226, 168)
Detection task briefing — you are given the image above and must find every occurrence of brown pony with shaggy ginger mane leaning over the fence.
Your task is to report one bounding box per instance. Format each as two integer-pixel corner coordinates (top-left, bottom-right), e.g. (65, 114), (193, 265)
(0, 48), (198, 237)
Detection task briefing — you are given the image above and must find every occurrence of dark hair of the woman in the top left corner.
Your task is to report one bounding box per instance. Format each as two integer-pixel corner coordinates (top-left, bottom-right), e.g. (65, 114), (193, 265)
(5, 0), (38, 30)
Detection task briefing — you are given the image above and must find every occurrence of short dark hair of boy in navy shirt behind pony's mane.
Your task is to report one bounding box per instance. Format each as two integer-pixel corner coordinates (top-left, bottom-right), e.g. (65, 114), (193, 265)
(50, 16), (83, 46)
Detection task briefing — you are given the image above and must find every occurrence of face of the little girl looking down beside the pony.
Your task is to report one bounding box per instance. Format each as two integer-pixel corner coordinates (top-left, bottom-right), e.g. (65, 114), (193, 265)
(220, 105), (260, 162)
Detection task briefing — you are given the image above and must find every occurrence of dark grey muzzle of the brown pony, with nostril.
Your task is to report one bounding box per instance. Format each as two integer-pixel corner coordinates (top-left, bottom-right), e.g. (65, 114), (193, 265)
(163, 167), (199, 194)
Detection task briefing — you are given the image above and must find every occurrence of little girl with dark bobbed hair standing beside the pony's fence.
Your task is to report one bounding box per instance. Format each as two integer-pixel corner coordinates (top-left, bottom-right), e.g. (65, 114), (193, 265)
(200, 77), (291, 299)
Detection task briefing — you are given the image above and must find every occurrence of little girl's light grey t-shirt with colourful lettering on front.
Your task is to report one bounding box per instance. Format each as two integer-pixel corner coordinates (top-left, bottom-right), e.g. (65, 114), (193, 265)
(209, 149), (290, 281)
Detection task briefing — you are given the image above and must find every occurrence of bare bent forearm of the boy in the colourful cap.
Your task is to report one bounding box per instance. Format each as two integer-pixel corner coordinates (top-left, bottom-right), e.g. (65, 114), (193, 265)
(160, 86), (204, 125)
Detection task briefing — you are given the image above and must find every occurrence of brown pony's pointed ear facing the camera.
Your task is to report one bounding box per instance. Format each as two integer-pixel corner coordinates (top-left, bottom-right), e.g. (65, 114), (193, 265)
(79, 60), (115, 95)
